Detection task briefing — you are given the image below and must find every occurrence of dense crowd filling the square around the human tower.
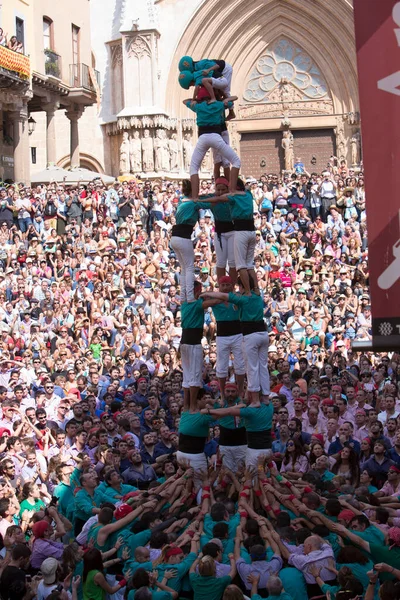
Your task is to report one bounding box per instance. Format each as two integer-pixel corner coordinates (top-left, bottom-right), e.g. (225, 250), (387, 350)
(0, 161), (400, 600)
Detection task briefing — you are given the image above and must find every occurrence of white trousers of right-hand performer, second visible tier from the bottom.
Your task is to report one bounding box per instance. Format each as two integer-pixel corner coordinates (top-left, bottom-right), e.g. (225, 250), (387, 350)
(243, 331), (270, 394)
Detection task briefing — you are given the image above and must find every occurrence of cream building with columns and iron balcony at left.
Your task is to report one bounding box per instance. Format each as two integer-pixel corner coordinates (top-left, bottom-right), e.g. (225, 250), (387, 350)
(0, 0), (102, 182)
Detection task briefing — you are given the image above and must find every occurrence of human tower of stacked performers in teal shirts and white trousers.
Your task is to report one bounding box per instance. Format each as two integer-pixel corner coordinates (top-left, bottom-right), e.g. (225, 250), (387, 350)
(175, 51), (273, 482)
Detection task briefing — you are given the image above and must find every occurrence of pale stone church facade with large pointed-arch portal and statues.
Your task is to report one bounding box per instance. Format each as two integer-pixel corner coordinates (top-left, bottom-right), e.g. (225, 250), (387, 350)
(91, 0), (361, 178)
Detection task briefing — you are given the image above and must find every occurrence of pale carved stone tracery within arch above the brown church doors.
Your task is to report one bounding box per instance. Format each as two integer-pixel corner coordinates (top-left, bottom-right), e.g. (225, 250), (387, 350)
(243, 37), (330, 105)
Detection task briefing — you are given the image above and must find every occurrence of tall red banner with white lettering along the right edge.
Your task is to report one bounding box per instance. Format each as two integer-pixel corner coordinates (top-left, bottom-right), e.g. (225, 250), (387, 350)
(354, 0), (400, 349)
